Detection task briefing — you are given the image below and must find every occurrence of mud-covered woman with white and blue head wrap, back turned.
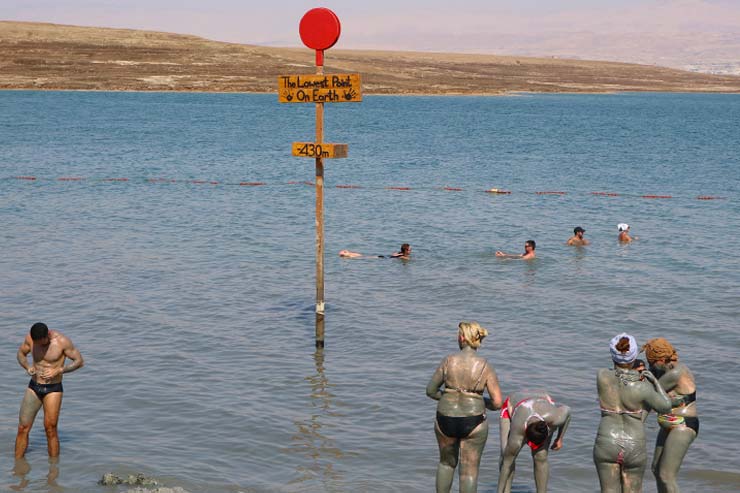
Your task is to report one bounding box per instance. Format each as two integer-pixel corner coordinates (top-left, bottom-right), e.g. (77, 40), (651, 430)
(594, 333), (671, 493)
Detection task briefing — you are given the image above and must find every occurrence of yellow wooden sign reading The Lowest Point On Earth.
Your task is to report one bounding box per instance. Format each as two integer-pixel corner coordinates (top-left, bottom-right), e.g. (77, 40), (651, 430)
(278, 74), (362, 103)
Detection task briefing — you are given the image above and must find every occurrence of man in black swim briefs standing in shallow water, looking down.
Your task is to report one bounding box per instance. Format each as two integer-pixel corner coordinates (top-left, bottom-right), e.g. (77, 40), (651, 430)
(15, 322), (84, 459)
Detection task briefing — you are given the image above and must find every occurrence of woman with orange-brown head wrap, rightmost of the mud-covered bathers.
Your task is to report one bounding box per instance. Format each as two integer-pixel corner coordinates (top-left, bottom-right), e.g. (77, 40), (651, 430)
(642, 337), (699, 493)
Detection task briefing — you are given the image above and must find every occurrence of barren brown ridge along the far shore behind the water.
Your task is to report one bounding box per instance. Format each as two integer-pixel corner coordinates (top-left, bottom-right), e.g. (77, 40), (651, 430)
(0, 21), (740, 95)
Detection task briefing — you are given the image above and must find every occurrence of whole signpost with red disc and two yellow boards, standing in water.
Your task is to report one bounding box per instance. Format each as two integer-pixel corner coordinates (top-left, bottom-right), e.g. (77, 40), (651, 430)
(278, 7), (362, 348)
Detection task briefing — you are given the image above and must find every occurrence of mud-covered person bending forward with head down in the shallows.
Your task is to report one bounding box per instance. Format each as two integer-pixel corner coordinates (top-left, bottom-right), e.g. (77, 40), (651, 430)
(498, 392), (570, 493)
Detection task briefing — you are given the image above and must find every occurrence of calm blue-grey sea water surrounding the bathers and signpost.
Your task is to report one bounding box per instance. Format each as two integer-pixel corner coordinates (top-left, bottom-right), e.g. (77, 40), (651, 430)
(0, 92), (740, 493)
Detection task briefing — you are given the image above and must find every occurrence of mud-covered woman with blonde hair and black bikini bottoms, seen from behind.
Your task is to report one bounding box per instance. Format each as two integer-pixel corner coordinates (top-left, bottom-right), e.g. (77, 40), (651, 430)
(427, 322), (501, 493)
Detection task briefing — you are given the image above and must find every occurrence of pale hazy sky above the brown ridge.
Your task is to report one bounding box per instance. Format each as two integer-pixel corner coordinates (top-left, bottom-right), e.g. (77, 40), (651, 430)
(0, 0), (740, 51)
